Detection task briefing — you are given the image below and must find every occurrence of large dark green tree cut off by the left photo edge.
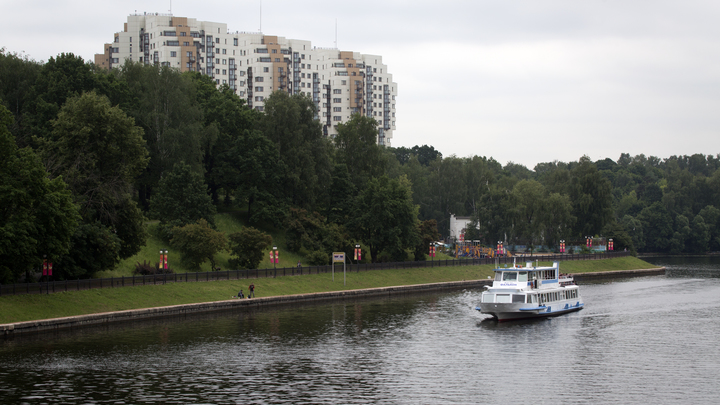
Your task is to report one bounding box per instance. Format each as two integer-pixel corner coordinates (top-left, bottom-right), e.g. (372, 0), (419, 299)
(0, 105), (79, 283)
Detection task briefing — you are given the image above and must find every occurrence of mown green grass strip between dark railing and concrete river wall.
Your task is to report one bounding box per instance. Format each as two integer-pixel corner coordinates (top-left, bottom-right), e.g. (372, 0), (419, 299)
(0, 257), (655, 324)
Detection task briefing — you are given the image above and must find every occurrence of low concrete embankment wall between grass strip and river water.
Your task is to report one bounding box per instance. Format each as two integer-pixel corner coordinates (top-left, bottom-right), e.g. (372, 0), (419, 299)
(0, 268), (665, 335)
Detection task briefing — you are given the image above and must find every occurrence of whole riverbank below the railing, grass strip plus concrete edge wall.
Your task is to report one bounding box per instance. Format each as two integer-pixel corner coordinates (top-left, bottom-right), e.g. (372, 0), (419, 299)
(0, 257), (658, 334)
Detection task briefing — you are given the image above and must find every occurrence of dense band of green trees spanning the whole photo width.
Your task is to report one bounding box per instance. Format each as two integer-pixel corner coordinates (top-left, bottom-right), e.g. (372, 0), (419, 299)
(0, 49), (720, 282)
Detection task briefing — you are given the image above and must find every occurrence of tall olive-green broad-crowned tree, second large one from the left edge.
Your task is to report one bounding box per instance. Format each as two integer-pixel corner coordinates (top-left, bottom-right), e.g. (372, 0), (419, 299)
(42, 92), (148, 259)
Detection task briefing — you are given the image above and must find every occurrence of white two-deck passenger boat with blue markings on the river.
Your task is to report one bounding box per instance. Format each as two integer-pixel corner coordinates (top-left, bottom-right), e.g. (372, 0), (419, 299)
(475, 262), (584, 321)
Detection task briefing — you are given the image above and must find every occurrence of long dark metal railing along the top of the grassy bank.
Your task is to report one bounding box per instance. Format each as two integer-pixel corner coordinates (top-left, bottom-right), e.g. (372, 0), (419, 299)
(0, 252), (630, 296)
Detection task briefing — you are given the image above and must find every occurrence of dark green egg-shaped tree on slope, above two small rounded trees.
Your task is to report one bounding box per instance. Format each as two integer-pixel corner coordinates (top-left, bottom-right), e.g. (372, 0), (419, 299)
(150, 162), (215, 240)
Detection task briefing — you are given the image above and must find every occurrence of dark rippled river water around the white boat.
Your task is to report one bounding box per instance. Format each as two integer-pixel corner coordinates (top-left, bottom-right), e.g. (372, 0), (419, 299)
(0, 259), (720, 404)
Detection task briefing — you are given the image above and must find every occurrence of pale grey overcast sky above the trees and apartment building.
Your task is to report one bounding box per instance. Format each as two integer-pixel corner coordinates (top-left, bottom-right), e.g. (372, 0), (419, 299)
(0, 0), (720, 169)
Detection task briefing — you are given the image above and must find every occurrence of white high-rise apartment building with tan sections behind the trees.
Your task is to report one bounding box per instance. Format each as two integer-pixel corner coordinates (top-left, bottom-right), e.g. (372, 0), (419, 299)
(95, 13), (397, 146)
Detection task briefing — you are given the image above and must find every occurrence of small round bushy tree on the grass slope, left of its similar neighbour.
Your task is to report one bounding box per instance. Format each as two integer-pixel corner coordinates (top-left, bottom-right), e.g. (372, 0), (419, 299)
(170, 218), (227, 271)
